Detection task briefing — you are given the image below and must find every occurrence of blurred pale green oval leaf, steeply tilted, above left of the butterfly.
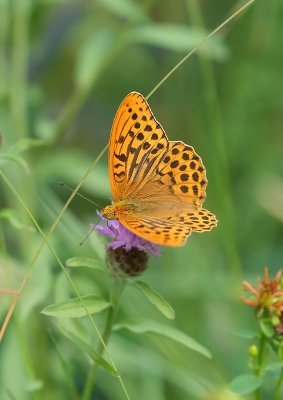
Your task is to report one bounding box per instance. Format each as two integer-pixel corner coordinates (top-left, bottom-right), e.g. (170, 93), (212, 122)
(74, 29), (117, 88)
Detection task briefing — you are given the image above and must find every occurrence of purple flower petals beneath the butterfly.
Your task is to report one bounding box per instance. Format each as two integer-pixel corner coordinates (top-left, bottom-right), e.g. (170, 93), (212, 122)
(92, 213), (162, 257)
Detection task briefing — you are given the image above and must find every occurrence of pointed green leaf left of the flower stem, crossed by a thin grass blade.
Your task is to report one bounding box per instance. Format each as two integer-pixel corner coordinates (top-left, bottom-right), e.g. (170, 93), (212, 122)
(41, 294), (111, 318)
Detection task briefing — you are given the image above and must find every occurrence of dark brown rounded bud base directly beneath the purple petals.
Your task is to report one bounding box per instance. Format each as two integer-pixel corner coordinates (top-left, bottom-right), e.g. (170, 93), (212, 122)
(106, 247), (148, 278)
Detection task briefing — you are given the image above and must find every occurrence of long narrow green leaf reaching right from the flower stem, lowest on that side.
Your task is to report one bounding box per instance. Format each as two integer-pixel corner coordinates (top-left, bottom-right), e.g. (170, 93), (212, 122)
(114, 321), (212, 358)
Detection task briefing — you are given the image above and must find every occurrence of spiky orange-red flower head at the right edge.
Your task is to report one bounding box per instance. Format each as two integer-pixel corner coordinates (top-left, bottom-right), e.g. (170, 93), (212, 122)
(241, 267), (283, 316)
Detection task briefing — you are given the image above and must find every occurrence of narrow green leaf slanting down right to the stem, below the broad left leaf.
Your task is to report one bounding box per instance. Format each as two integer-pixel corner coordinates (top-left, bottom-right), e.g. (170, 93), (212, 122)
(57, 324), (120, 378)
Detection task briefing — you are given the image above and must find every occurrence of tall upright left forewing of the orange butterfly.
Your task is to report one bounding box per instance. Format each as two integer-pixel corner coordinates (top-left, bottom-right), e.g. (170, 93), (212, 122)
(109, 92), (168, 201)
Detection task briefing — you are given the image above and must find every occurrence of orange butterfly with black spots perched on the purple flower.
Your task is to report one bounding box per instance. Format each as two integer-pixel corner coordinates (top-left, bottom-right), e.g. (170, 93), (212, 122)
(101, 92), (217, 246)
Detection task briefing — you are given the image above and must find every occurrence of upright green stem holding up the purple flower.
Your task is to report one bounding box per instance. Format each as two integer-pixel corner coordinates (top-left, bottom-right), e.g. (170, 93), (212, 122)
(81, 277), (128, 400)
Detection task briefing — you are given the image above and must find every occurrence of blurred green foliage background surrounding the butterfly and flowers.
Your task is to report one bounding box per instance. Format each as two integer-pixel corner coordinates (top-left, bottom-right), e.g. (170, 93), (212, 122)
(0, 0), (283, 400)
